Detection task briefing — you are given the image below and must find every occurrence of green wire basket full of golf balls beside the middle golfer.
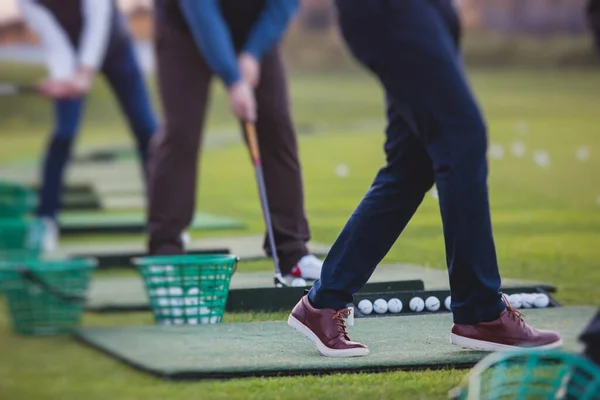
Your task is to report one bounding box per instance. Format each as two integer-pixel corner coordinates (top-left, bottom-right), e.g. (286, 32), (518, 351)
(134, 254), (238, 325)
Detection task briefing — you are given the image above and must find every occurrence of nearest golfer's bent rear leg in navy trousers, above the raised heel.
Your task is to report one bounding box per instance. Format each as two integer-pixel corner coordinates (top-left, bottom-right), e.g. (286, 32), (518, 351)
(309, 96), (433, 310)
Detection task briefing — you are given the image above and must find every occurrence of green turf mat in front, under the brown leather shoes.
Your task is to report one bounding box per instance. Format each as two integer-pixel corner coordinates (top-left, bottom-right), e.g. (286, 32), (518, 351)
(77, 307), (597, 380)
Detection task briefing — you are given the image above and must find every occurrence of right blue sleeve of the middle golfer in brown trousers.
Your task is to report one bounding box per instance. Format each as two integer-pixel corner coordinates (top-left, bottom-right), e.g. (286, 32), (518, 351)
(243, 0), (299, 60)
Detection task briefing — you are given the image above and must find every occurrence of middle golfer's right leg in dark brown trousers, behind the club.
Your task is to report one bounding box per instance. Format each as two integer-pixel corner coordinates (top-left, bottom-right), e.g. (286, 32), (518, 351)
(256, 48), (310, 275)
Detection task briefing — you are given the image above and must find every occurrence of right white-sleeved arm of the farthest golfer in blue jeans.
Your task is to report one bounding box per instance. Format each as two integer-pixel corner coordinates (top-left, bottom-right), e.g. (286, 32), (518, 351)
(77, 0), (113, 71)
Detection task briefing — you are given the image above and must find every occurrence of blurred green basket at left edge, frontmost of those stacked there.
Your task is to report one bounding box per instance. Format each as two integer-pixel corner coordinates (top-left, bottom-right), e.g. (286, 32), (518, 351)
(0, 259), (96, 336)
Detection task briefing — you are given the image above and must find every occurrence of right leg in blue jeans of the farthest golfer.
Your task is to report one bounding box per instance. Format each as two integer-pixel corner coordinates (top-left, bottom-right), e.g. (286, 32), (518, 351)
(102, 43), (157, 174)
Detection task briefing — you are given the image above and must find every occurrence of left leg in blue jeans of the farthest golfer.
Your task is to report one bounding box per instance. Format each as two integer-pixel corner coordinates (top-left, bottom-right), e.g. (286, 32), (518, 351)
(37, 99), (84, 220)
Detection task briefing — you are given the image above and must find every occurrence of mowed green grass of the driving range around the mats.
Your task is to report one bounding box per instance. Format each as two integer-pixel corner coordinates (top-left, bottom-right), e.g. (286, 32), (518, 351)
(0, 61), (600, 400)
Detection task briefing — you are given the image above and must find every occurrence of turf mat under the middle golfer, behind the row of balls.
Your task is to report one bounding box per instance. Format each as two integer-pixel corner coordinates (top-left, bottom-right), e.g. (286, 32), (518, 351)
(87, 262), (555, 311)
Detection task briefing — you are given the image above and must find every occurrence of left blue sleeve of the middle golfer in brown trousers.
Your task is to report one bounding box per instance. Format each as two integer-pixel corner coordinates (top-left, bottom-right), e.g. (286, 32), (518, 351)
(179, 0), (240, 87)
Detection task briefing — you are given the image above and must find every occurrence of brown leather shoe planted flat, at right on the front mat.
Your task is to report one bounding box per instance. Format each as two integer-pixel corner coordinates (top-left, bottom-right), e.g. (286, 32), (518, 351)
(450, 299), (563, 351)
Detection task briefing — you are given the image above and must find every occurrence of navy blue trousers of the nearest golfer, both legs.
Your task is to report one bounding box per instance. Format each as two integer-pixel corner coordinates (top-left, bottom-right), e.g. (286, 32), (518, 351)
(309, 0), (505, 324)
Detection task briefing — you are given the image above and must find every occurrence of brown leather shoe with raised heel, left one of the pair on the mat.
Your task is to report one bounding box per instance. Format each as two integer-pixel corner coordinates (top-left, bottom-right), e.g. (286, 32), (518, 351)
(288, 296), (369, 357)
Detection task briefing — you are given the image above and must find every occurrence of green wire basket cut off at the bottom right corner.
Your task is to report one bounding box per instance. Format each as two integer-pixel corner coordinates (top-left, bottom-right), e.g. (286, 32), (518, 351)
(450, 349), (600, 400)
